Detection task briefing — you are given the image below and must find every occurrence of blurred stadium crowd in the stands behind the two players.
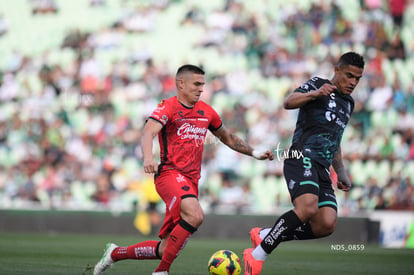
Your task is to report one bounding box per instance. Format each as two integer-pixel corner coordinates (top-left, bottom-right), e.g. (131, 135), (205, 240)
(0, 0), (414, 216)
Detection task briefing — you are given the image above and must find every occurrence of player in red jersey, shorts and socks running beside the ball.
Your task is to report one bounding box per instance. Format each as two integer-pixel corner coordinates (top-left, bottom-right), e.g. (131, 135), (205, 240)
(94, 64), (274, 275)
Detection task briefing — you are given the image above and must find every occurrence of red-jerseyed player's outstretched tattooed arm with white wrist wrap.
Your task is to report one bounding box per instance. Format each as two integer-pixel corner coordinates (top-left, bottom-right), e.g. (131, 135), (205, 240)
(212, 125), (274, 160)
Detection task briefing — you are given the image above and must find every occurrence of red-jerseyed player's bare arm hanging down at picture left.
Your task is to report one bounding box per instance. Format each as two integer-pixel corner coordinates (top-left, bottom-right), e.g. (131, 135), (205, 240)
(141, 119), (163, 174)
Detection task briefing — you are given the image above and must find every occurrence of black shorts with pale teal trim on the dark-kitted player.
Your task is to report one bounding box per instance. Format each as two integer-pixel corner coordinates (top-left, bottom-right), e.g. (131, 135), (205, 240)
(283, 157), (338, 211)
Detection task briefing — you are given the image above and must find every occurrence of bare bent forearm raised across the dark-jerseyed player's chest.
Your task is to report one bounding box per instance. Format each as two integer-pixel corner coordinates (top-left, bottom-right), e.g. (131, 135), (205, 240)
(283, 83), (336, 109)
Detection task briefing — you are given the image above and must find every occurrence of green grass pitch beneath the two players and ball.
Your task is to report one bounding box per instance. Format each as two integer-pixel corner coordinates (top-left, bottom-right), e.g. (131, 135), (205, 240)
(0, 232), (414, 275)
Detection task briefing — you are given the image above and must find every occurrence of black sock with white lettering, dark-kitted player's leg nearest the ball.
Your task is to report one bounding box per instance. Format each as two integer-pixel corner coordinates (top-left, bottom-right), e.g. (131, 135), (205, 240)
(260, 210), (303, 254)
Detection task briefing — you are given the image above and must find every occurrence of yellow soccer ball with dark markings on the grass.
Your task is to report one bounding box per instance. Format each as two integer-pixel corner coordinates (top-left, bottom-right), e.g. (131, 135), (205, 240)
(208, 250), (241, 275)
